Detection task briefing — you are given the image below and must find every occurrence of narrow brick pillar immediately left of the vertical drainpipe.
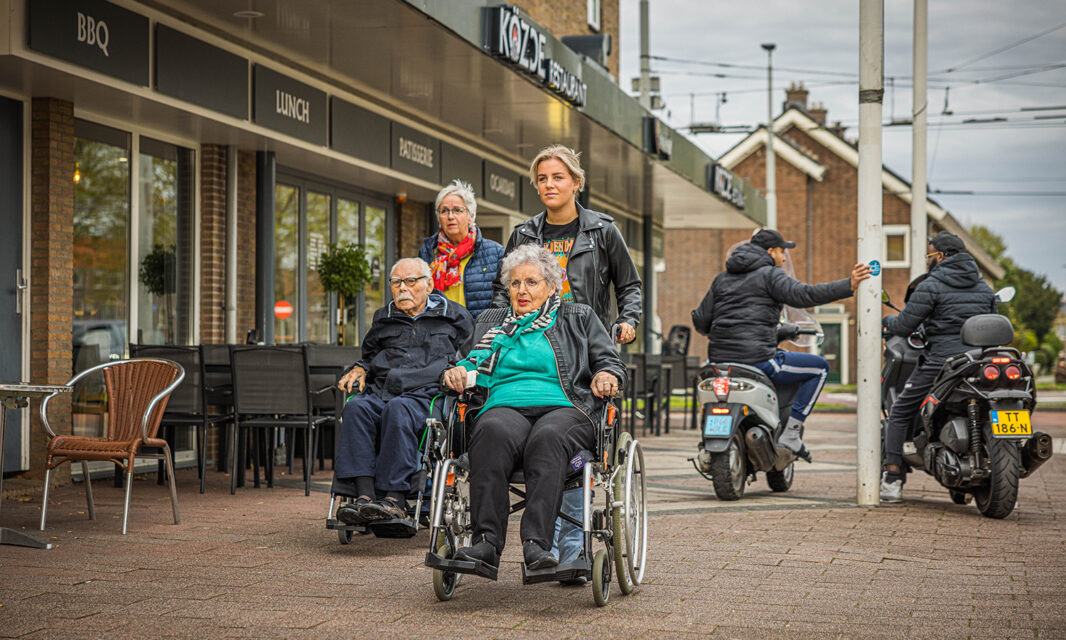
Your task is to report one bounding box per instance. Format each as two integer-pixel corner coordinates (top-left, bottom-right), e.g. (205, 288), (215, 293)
(199, 144), (226, 345)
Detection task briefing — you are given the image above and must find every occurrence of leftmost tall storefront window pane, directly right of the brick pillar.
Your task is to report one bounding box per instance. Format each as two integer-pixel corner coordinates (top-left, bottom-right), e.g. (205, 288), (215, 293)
(71, 121), (130, 420)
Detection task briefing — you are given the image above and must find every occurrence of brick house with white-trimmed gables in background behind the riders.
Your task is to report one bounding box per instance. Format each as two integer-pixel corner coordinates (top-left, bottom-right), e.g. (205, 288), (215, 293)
(659, 83), (1003, 383)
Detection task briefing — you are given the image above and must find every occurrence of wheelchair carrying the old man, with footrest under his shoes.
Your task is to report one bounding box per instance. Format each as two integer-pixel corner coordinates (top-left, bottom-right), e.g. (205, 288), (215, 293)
(326, 396), (439, 544)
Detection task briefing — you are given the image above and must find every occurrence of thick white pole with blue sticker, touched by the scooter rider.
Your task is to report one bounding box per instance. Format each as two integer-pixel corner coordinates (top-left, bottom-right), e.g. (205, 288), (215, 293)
(855, 0), (885, 506)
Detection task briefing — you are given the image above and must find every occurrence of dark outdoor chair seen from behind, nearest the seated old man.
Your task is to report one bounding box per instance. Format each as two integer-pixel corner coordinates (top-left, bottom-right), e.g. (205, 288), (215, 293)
(229, 346), (329, 496)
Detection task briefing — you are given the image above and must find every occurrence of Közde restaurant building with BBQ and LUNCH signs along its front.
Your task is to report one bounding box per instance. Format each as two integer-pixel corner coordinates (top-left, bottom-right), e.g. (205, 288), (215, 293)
(0, 0), (761, 474)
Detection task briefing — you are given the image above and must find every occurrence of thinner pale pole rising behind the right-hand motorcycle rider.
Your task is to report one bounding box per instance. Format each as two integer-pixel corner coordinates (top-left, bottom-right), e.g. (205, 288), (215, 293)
(910, 0), (928, 279)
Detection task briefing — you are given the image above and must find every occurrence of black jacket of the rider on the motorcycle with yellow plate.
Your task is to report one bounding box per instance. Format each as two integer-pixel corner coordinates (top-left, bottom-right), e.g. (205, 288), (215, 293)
(882, 253), (996, 358)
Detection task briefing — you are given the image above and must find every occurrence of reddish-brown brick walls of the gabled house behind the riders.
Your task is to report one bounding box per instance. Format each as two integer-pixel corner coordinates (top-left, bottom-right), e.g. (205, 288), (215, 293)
(659, 113), (929, 380)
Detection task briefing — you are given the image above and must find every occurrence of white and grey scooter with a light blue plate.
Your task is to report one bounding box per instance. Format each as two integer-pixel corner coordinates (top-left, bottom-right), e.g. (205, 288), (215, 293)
(690, 319), (822, 500)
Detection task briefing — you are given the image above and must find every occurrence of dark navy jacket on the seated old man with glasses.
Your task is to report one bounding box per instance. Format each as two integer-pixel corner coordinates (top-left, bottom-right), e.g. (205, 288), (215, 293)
(353, 291), (473, 400)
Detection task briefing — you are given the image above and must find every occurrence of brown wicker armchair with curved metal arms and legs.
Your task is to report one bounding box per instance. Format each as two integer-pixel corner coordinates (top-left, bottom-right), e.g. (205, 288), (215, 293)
(41, 358), (184, 535)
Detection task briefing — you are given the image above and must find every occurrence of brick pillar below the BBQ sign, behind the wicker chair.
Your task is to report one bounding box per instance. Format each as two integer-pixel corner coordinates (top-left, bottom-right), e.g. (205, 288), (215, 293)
(30, 98), (74, 482)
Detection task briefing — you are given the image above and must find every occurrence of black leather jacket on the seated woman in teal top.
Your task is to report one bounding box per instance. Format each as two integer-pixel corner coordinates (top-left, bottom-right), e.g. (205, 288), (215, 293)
(474, 303), (628, 425)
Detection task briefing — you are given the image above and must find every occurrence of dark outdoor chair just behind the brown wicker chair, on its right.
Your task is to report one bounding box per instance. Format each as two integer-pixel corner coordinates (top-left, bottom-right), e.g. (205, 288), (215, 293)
(130, 345), (233, 493)
